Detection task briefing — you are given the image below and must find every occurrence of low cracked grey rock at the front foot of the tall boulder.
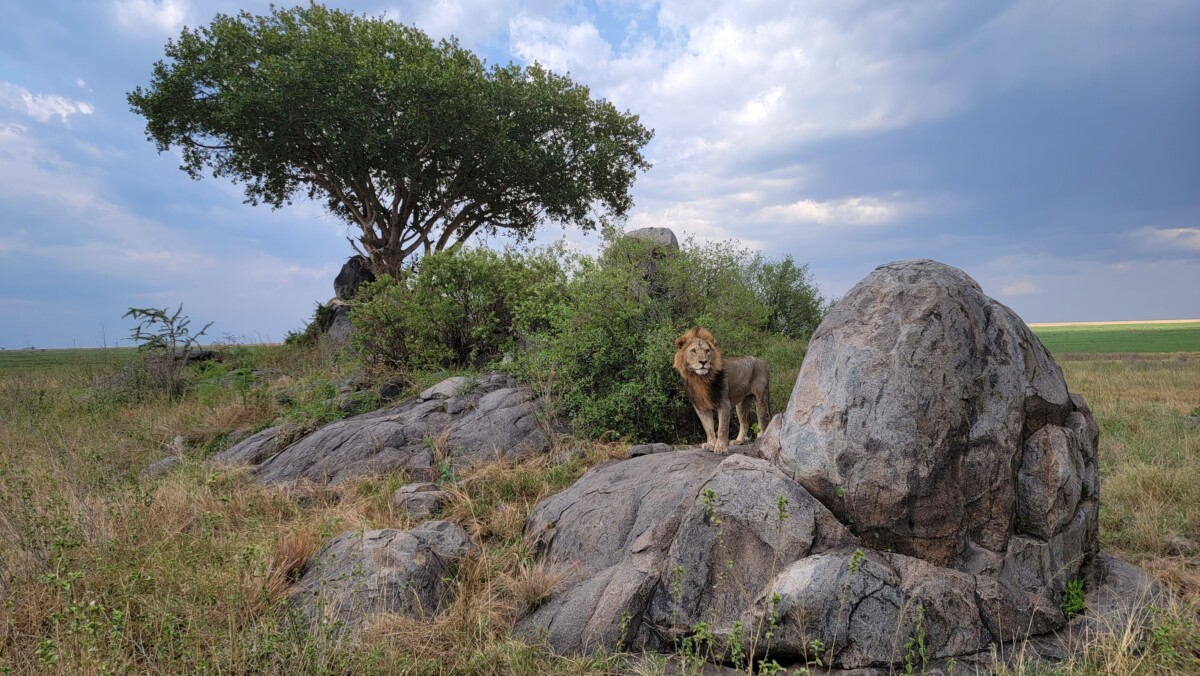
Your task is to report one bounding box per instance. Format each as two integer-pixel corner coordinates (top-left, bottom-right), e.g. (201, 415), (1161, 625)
(742, 548), (1063, 669)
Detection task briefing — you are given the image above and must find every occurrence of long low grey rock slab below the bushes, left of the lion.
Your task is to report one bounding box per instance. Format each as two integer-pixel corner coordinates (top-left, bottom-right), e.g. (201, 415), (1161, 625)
(214, 375), (550, 484)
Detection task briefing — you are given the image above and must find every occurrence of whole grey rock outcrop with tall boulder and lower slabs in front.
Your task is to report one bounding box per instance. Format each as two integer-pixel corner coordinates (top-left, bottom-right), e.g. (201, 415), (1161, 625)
(517, 261), (1158, 672)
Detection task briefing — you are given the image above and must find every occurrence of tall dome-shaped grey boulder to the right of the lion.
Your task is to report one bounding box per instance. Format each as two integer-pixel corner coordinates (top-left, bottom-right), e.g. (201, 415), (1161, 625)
(766, 261), (1098, 594)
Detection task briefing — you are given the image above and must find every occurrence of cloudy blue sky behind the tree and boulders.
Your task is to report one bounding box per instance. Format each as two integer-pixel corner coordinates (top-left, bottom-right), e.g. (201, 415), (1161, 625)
(0, 0), (1200, 349)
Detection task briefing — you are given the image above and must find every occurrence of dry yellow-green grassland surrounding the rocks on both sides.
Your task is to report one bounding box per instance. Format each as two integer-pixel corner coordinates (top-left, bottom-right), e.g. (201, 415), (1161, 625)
(0, 347), (1200, 674)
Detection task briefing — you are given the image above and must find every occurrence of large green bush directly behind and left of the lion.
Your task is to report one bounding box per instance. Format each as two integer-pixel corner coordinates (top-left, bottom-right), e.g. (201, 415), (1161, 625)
(521, 238), (823, 441)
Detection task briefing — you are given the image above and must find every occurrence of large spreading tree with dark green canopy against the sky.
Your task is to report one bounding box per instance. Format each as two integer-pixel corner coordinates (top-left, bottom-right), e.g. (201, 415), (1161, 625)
(128, 4), (653, 273)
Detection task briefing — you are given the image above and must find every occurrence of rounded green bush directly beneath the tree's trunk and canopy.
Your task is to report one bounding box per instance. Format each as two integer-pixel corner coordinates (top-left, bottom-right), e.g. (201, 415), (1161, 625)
(350, 249), (565, 370)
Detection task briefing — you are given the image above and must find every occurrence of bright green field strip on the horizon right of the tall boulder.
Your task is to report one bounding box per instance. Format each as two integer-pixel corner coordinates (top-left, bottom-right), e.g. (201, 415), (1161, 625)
(1031, 322), (1200, 354)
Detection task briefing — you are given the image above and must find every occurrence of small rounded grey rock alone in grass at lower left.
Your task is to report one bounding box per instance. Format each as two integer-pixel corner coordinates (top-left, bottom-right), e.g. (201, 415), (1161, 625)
(290, 521), (470, 626)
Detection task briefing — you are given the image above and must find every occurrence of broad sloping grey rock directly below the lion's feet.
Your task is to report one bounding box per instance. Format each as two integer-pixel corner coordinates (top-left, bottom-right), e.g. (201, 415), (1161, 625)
(516, 450), (854, 654)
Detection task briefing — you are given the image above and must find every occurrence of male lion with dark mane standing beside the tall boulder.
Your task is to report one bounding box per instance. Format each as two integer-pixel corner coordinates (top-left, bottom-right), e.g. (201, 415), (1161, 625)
(674, 327), (770, 454)
